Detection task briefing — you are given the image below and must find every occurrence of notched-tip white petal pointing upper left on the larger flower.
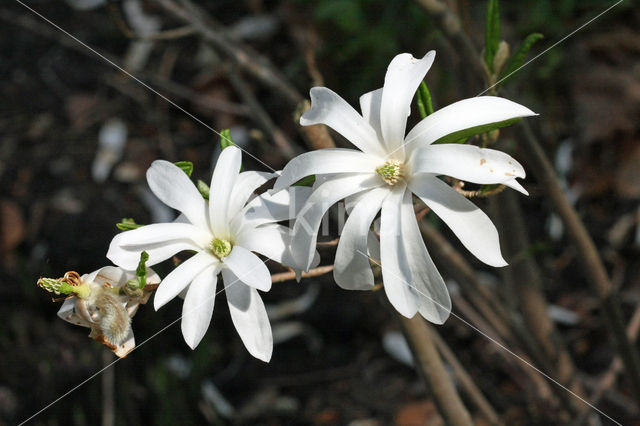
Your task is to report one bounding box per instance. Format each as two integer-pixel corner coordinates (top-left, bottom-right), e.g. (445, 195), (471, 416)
(300, 87), (385, 158)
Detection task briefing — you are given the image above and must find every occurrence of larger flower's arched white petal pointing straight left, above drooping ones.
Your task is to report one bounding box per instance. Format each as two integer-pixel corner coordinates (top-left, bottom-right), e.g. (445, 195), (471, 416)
(273, 148), (384, 191)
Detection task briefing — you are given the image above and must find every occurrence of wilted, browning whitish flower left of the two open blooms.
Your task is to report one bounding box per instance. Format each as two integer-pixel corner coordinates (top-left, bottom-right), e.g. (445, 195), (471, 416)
(55, 266), (160, 358)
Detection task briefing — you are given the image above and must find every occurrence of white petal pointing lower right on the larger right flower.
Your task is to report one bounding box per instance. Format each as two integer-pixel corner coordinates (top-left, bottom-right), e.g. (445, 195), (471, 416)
(409, 174), (507, 266)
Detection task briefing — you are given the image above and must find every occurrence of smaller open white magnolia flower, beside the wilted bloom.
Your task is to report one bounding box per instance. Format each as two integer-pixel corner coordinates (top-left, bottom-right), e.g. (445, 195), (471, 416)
(107, 146), (309, 361)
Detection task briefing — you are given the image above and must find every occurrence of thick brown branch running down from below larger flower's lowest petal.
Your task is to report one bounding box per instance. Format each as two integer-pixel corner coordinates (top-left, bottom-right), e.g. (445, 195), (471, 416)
(398, 314), (473, 426)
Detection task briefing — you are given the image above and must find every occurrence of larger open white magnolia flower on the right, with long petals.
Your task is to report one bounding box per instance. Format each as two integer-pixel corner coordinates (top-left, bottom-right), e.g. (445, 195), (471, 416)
(274, 51), (535, 324)
